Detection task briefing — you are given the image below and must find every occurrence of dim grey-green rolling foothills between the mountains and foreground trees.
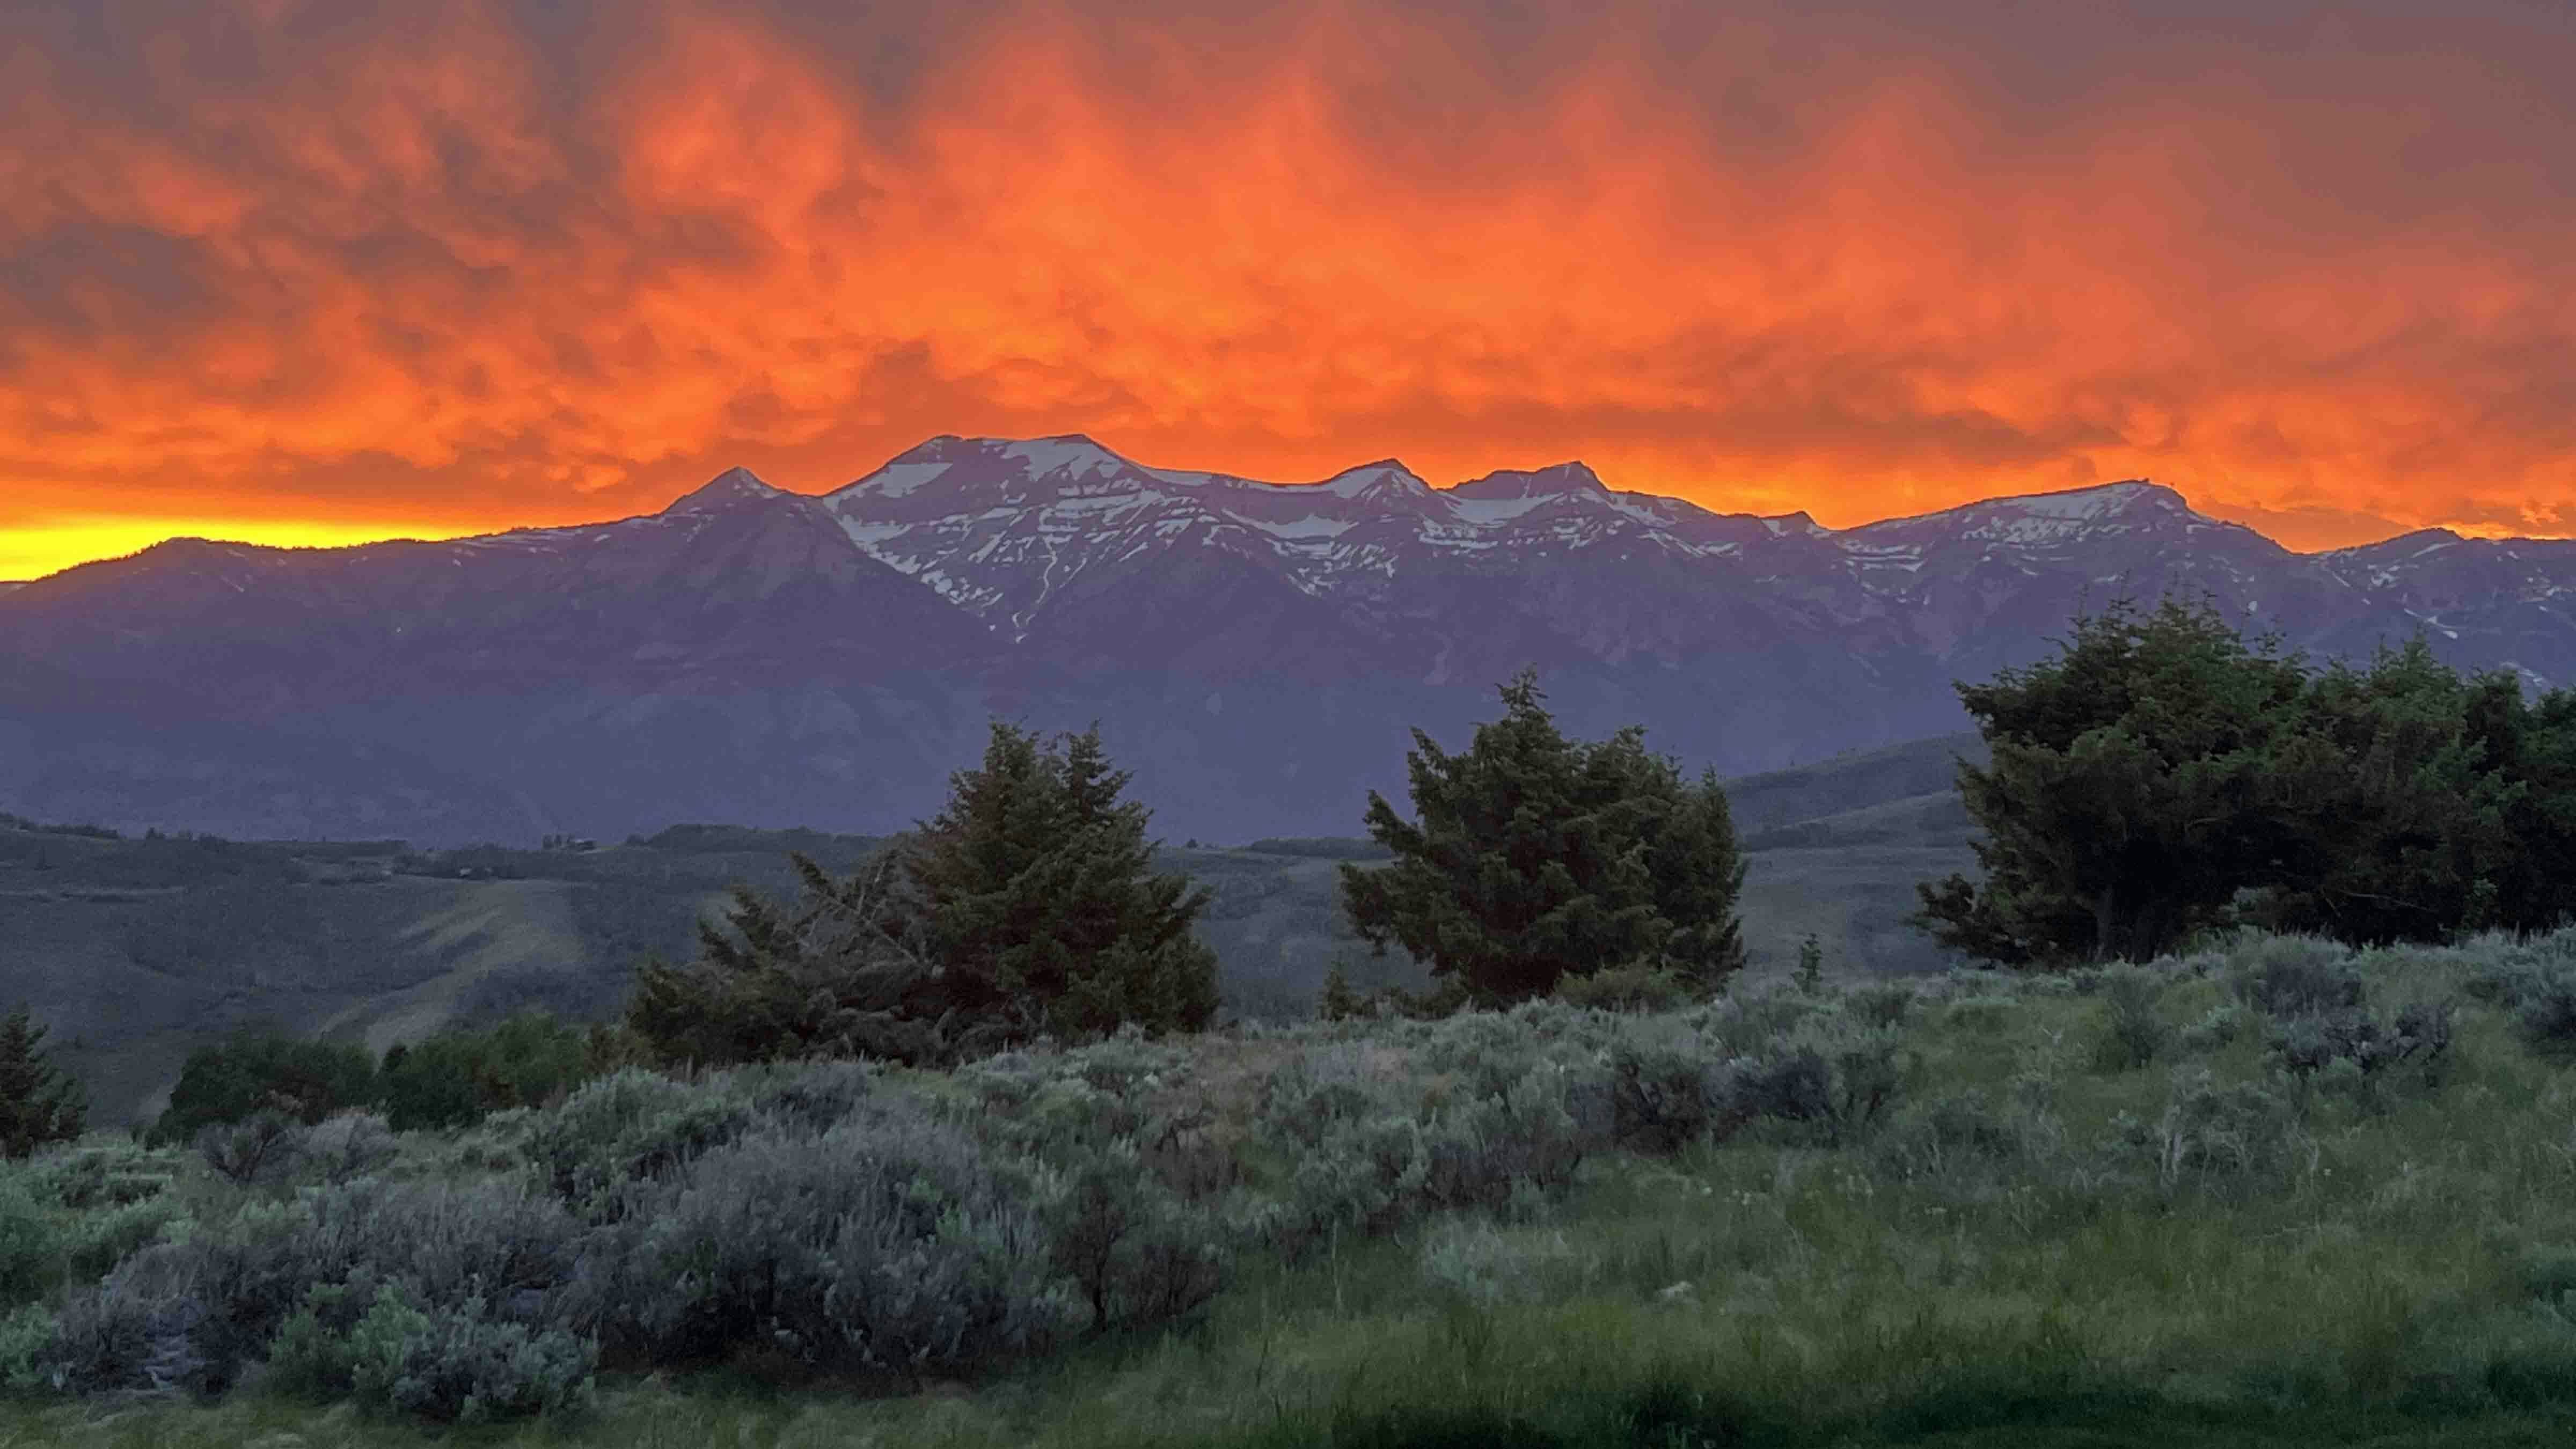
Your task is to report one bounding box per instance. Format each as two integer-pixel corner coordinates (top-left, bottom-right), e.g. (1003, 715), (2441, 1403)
(0, 737), (1971, 1124)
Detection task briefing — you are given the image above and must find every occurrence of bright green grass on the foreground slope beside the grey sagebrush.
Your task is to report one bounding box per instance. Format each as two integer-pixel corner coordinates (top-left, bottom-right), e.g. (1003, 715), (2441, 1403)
(0, 928), (2576, 1449)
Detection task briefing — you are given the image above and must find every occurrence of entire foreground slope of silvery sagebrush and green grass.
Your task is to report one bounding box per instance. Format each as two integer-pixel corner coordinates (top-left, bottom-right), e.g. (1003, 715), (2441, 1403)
(0, 933), (2576, 1446)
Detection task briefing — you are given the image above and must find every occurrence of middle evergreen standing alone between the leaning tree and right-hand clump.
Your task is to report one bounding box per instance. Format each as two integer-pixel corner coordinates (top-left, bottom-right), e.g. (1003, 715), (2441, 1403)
(1340, 670), (1744, 1003)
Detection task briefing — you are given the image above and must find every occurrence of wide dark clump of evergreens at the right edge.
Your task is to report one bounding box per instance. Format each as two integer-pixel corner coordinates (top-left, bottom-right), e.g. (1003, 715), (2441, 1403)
(1916, 601), (2576, 964)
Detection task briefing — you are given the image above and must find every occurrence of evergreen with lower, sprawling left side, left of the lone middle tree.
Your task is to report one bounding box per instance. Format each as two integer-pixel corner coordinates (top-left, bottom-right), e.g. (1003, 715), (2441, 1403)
(626, 722), (1216, 1065)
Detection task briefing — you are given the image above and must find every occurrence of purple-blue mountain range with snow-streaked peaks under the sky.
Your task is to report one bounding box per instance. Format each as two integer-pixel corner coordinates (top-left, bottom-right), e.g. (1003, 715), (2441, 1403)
(0, 436), (2576, 843)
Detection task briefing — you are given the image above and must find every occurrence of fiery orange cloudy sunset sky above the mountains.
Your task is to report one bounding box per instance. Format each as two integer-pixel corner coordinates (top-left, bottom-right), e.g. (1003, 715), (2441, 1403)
(0, 0), (2576, 577)
